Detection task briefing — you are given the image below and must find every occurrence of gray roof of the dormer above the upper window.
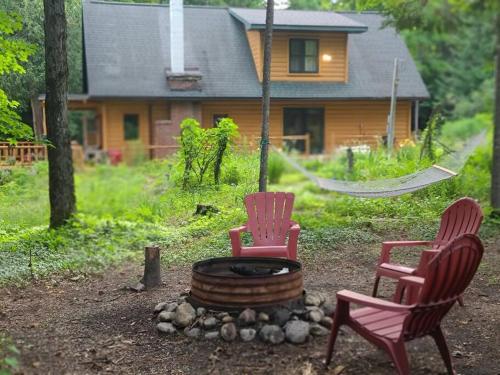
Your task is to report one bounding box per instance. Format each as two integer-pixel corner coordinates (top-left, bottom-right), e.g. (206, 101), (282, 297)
(229, 8), (367, 33)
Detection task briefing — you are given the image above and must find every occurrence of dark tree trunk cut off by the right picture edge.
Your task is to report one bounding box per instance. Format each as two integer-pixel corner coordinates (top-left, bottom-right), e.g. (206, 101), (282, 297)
(491, 15), (500, 215)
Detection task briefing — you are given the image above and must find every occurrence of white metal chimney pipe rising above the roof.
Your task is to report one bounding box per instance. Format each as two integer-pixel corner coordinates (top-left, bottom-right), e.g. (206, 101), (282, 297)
(170, 0), (184, 74)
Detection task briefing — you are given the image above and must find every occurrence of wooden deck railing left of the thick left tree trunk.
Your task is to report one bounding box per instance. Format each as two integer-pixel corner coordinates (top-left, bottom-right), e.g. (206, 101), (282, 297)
(0, 142), (47, 166)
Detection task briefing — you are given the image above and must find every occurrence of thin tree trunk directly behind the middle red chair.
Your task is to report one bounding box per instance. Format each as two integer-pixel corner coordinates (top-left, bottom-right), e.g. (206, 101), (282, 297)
(259, 0), (274, 191)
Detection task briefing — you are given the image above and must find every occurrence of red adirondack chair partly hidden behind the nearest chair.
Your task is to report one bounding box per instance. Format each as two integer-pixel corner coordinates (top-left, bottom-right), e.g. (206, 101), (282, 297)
(372, 198), (483, 305)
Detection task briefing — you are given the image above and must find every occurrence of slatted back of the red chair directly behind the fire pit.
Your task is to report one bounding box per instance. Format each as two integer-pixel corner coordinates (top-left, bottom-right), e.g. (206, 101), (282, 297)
(245, 192), (295, 246)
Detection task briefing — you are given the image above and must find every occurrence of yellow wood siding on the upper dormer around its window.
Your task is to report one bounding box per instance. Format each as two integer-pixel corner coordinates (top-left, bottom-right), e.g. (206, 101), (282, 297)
(247, 30), (349, 82)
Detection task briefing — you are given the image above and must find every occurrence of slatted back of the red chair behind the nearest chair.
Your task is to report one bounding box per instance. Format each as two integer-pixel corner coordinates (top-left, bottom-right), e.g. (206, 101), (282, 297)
(433, 198), (483, 249)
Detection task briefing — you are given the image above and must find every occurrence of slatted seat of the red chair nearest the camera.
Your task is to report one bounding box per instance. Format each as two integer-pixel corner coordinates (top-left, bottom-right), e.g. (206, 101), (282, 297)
(350, 307), (409, 341)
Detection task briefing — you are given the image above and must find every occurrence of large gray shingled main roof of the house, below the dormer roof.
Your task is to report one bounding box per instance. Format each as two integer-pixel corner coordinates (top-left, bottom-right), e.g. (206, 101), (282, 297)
(83, 0), (428, 99)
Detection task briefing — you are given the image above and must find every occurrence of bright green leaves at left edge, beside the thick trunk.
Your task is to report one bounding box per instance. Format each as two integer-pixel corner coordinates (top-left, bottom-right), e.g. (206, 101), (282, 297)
(0, 11), (34, 144)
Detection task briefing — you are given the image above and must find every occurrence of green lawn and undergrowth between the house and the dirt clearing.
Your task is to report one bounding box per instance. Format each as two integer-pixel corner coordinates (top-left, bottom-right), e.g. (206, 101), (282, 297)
(0, 113), (496, 283)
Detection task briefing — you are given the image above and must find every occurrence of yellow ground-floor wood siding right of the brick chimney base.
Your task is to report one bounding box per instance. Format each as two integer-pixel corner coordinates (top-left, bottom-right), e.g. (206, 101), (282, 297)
(202, 100), (411, 152)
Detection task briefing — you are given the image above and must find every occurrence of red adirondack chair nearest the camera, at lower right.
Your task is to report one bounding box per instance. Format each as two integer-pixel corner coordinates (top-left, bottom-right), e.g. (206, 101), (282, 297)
(326, 234), (483, 375)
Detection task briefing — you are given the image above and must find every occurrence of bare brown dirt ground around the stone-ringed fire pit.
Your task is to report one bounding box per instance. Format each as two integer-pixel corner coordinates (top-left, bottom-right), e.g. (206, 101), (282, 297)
(0, 241), (500, 375)
